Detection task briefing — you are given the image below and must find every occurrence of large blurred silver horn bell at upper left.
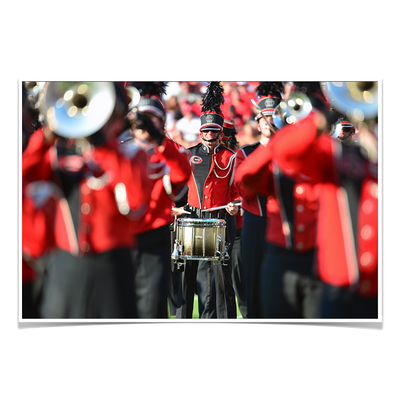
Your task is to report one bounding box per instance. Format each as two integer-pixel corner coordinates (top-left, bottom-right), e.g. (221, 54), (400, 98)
(41, 82), (116, 139)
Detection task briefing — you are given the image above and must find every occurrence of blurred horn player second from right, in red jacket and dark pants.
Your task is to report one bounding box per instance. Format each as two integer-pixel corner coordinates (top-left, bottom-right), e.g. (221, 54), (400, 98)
(236, 82), (326, 318)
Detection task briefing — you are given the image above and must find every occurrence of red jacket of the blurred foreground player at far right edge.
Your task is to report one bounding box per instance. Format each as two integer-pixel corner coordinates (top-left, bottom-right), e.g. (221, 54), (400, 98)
(271, 112), (378, 297)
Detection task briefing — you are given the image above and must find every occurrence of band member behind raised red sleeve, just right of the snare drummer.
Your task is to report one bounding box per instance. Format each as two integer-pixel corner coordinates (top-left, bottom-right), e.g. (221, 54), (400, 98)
(236, 82), (283, 318)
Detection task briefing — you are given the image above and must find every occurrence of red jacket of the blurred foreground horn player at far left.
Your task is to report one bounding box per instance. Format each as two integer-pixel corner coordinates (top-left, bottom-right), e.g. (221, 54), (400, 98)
(22, 127), (151, 256)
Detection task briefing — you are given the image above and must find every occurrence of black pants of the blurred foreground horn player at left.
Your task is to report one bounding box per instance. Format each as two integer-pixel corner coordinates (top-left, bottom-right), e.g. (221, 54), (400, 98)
(41, 248), (137, 319)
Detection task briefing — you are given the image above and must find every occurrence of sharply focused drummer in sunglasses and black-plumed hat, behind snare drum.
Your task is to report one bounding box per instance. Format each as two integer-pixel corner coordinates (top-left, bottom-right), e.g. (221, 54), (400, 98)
(176, 82), (240, 318)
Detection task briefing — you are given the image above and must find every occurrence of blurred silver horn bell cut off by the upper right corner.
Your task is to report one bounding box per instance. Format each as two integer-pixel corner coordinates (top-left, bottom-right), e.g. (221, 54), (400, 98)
(321, 82), (378, 122)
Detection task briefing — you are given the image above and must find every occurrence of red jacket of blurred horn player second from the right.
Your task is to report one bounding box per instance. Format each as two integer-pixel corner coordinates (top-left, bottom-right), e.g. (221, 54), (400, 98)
(235, 141), (318, 253)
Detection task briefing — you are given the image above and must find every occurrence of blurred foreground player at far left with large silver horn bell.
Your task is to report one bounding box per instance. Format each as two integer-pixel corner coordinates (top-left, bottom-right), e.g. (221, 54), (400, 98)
(22, 82), (150, 318)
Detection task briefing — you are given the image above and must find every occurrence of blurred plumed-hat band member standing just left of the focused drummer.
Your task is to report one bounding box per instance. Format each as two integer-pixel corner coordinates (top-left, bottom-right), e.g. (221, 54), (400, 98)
(121, 82), (191, 318)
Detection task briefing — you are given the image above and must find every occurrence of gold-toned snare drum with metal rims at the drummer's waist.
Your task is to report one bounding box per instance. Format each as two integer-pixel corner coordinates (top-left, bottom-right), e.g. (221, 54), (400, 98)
(176, 218), (226, 260)
